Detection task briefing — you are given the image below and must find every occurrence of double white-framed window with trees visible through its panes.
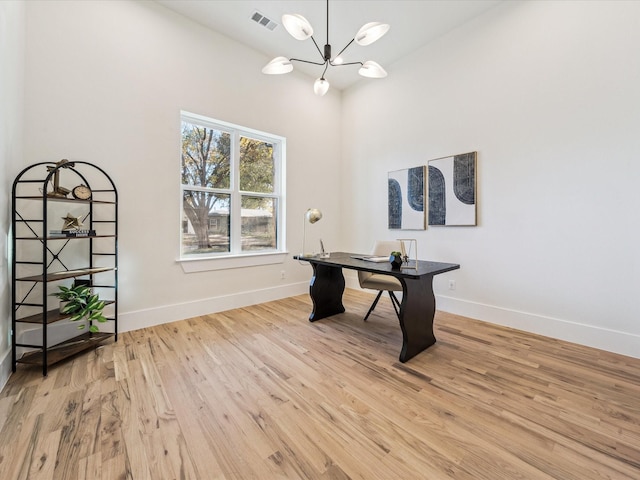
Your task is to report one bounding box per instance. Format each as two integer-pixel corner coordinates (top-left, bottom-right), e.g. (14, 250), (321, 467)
(180, 112), (285, 259)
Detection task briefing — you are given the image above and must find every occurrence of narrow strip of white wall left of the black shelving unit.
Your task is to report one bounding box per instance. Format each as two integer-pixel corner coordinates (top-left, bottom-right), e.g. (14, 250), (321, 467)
(0, 1), (25, 388)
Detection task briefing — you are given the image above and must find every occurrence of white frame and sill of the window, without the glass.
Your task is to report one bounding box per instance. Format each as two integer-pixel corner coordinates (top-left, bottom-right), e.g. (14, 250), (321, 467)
(178, 111), (288, 273)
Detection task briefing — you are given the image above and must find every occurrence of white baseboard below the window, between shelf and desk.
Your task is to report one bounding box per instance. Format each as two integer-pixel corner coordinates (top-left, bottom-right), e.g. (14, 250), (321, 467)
(118, 282), (309, 332)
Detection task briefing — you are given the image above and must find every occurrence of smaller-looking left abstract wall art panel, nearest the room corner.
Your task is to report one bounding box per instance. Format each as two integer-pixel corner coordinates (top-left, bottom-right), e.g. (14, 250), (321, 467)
(388, 166), (426, 230)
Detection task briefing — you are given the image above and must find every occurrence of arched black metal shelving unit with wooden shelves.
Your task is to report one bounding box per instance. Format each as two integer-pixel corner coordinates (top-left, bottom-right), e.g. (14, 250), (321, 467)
(11, 160), (118, 376)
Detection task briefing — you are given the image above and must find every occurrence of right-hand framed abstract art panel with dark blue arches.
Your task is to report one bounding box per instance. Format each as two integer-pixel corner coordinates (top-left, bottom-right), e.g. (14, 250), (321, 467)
(427, 152), (477, 225)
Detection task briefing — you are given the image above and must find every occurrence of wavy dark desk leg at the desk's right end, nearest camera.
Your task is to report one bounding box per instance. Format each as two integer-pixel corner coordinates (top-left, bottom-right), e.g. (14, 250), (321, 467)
(400, 275), (436, 363)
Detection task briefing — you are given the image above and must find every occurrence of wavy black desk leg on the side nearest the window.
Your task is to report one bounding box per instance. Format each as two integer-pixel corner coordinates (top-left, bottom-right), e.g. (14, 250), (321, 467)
(309, 263), (345, 322)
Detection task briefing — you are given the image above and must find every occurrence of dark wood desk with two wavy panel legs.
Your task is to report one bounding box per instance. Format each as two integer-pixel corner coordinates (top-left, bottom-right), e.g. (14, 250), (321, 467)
(294, 252), (460, 362)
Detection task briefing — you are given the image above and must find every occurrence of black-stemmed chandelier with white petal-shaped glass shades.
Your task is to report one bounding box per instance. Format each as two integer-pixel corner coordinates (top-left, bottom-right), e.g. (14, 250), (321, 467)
(262, 0), (390, 95)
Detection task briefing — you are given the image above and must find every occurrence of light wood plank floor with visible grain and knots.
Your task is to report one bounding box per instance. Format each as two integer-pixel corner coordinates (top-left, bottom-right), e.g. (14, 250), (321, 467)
(0, 290), (640, 480)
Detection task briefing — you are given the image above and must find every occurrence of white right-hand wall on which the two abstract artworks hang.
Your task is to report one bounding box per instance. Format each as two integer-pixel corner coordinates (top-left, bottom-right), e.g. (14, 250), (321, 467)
(342, 1), (640, 356)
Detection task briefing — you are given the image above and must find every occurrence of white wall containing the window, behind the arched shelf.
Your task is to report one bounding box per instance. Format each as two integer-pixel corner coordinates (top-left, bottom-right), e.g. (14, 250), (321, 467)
(25, 1), (341, 331)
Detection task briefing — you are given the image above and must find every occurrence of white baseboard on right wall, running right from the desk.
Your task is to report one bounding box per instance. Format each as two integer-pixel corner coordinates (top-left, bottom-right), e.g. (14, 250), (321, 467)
(436, 295), (640, 358)
